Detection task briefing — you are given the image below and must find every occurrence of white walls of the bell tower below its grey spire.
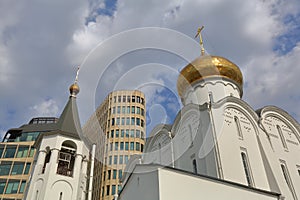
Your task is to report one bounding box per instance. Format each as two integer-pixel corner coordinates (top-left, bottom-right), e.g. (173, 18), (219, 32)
(27, 135), (89, 200)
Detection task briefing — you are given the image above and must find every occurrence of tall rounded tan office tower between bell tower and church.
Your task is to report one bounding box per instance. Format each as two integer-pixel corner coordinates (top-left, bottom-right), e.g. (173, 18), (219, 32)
(83, 90), (146, 200)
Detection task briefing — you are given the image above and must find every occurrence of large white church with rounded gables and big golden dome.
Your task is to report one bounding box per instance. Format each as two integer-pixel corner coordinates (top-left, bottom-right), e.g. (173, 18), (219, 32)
(118, 36), (300, 200)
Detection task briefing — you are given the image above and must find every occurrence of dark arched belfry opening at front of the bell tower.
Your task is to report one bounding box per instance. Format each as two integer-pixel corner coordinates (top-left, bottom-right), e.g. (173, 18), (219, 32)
(57, 140), (77, 176)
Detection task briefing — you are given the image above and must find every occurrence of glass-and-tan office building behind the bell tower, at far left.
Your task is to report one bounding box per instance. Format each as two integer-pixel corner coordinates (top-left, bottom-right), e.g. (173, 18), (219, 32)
(0, 117), (58, 200)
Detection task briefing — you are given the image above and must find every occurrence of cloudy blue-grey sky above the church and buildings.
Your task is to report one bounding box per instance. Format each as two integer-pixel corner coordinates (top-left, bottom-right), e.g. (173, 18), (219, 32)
(0, 0), (300, 139)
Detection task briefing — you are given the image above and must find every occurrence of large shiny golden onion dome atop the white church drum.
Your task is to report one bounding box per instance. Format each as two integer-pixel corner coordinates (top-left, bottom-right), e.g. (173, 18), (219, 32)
(177, 55), (243, 97)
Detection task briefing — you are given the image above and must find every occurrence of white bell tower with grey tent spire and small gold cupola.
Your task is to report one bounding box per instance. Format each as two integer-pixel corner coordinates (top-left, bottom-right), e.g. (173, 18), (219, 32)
(26, 69), (89, 200)
